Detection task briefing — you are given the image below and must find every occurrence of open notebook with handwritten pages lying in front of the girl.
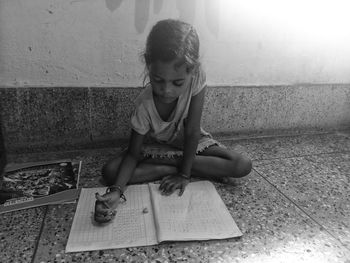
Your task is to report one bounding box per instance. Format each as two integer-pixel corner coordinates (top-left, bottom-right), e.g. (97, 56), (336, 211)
(66, 181), (242, 252)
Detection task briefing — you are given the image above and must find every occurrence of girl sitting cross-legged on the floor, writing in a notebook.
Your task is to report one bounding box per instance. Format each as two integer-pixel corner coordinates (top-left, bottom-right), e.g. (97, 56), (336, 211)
(95, 19), (252, 225)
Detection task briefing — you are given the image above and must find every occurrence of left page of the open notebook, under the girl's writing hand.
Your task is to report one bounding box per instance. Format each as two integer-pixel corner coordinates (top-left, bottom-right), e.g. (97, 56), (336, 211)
(66, 184), (157, 252)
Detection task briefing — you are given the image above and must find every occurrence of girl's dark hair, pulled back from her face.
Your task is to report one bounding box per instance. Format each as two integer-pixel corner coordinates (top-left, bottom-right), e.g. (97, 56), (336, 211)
(143, 19), (199, 72)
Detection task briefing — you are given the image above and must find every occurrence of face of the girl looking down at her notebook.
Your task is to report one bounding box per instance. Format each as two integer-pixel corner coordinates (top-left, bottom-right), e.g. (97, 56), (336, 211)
(149, 60), (191, 103)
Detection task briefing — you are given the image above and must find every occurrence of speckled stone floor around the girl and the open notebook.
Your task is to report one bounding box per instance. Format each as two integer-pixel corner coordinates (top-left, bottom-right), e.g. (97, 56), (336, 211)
(0, 132), (350, 263)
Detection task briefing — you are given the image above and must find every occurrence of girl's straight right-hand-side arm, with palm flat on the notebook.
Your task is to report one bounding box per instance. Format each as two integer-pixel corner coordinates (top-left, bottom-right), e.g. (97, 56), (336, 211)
(159, 87), (205, 195)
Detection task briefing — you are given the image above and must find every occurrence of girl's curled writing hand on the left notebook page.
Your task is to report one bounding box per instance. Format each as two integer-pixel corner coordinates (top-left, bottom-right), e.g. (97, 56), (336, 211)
(94, 191), (120, 223)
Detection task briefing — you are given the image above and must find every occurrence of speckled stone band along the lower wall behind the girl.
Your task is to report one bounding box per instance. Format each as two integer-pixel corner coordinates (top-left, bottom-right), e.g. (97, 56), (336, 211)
(0, 84), (350, 152)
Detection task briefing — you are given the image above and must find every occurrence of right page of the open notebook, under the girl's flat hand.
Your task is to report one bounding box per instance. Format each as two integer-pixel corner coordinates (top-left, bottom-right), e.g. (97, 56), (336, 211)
(150, 181), (242, 242)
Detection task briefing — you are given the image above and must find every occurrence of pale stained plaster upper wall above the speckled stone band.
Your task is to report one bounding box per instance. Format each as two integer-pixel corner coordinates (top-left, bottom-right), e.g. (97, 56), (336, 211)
(0, 0), (350, 87)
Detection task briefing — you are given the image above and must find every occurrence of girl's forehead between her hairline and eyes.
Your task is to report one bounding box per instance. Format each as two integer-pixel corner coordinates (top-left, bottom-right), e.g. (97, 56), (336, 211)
(149, 60), (189, 79)
